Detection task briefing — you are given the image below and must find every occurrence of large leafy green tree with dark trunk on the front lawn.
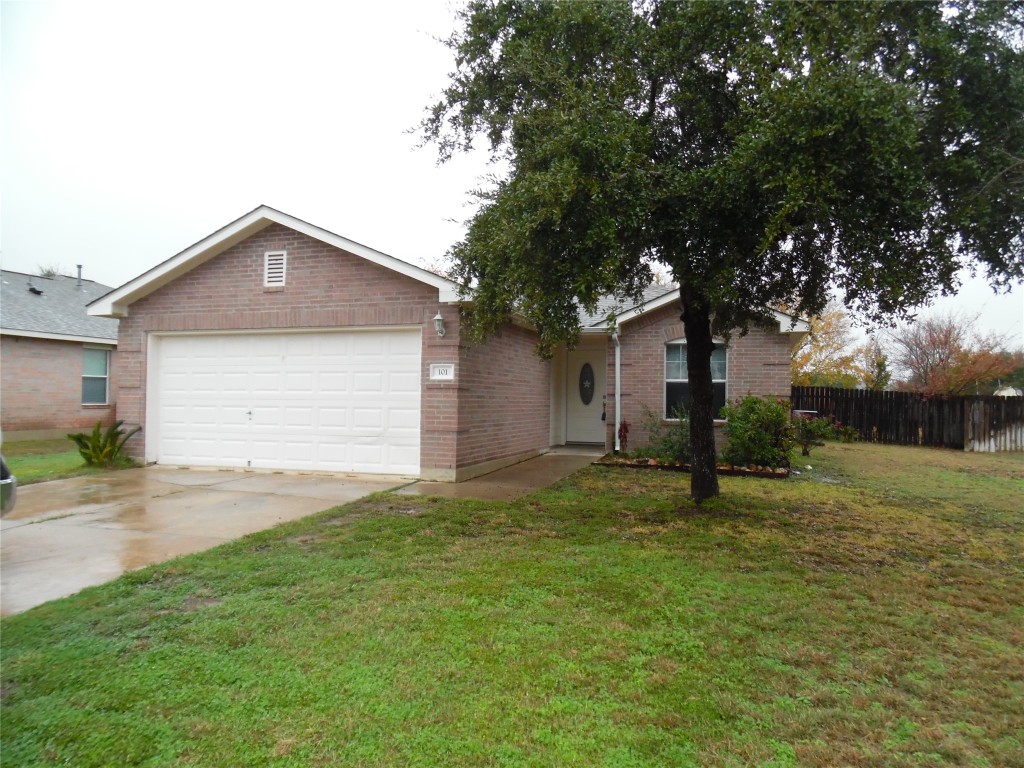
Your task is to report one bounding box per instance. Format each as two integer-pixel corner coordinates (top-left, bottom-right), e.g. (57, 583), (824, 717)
(422, 0), (1024, 502)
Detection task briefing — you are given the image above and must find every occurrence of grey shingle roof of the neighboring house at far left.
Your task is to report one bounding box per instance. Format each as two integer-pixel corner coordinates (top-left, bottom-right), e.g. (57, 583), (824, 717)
(0, 269), (118, 344)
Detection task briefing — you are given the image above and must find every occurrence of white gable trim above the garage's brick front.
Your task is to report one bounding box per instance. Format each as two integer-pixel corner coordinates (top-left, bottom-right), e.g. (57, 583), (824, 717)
(89, 206), (459, 317)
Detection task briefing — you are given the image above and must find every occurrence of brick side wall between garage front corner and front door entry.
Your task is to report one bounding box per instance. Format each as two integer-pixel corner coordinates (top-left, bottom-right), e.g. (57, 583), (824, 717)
(457, 326), (551, 467)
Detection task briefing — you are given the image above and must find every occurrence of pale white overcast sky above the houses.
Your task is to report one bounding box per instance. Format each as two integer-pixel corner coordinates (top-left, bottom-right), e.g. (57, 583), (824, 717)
(0, 0), (1024, 344)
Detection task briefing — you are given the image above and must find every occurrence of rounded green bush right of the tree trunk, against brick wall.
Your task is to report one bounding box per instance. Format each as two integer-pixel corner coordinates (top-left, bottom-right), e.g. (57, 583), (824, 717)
(722, 396), (796, 467)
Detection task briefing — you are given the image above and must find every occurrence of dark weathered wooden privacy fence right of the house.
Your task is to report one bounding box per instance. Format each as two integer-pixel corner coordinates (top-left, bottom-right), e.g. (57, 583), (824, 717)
(792, 387), (1024, 452)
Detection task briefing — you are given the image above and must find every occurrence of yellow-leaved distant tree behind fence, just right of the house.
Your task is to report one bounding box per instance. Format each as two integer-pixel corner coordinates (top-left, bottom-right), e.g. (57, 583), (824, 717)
(792, 302), (860, 387)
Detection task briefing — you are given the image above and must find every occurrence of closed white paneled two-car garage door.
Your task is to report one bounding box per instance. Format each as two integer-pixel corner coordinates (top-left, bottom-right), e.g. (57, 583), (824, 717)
(147, 329), (420, 474)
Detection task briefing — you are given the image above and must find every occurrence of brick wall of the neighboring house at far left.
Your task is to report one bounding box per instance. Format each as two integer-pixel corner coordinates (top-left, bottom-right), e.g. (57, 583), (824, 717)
(0, 335), (117, 444)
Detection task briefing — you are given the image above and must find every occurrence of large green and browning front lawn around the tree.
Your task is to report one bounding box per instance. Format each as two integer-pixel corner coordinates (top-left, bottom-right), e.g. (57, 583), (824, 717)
(2, 444), (1024, 768)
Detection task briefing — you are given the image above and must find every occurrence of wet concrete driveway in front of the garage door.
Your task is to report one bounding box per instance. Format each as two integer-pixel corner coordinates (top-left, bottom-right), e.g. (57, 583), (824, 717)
(0, 467), (412, 615)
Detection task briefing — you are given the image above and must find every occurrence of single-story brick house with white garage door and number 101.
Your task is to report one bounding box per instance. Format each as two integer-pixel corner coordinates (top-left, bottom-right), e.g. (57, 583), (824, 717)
(89, 206), (806, 480)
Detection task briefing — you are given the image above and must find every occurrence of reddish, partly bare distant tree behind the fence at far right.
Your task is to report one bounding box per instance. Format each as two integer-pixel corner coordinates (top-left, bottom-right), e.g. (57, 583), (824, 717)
(888, 314), (1021, 394)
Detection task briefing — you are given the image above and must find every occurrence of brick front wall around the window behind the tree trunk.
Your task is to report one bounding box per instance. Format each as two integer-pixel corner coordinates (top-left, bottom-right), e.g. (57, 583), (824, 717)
(608, 305), (792, 447)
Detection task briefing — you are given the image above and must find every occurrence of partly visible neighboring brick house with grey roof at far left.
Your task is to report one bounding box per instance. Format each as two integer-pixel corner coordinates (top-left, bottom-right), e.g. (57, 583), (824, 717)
(0, 270), (118, 440)
